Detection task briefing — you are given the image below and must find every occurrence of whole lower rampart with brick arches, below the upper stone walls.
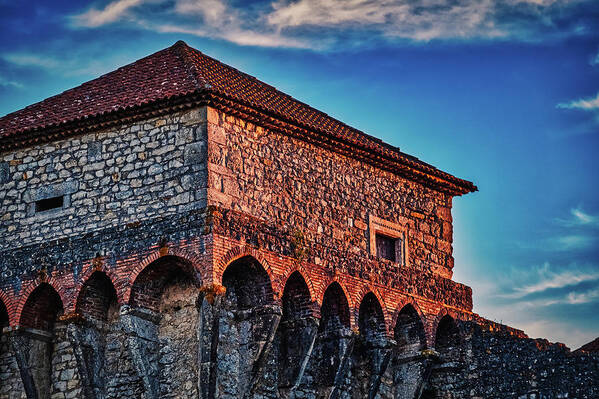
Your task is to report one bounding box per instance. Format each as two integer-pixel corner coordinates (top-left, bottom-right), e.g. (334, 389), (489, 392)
(0, 209), (599, 399)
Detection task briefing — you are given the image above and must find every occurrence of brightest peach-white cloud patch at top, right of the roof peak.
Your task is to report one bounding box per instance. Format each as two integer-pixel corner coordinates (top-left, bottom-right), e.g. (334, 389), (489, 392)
(267, 0), (509, 41)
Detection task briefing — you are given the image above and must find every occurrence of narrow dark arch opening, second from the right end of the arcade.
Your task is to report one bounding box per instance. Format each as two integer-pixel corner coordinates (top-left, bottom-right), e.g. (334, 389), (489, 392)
(393, 303), (427, 355)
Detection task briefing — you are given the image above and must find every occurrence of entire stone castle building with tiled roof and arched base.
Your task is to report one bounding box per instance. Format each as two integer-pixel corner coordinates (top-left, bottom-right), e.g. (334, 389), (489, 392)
(0, 42), (599, 399)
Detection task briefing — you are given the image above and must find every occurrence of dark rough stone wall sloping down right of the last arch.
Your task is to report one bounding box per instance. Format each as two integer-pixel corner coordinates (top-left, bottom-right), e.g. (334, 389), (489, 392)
(422, 321), (599, 399)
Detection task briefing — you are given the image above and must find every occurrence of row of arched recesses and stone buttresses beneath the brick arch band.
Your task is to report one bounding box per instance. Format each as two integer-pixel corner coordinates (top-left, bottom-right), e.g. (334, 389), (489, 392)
(0, 255), (486, 398)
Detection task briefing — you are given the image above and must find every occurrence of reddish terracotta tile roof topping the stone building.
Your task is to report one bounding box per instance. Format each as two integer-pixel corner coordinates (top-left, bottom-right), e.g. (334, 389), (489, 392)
(0, 41), (476, 194)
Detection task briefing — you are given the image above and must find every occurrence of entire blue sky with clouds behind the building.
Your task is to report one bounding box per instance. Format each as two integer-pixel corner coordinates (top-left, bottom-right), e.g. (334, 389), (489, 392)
(0, 0), (599, 348)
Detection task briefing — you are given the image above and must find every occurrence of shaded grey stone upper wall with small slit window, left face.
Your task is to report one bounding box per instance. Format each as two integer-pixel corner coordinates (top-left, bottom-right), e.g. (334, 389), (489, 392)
(0, 108), (206, 250)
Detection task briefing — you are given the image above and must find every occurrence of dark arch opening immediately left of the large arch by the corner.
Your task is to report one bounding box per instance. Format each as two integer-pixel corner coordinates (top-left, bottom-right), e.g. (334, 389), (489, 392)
(75, 270), (118, 321)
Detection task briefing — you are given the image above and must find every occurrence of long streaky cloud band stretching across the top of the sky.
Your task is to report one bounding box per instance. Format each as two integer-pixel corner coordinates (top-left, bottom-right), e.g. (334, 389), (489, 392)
(71, 0), (599, 49)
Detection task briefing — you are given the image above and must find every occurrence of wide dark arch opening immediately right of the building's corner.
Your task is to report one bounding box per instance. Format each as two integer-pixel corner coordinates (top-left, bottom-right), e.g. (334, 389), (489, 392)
(221, 256), (274, 309)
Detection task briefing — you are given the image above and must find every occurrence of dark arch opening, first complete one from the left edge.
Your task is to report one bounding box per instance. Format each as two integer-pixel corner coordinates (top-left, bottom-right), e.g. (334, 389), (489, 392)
(19, 283), (64, 332)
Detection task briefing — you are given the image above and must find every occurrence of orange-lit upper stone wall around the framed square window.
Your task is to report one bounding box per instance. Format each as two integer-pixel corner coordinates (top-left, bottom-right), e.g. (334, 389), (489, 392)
(208, 108), (453, 278)
